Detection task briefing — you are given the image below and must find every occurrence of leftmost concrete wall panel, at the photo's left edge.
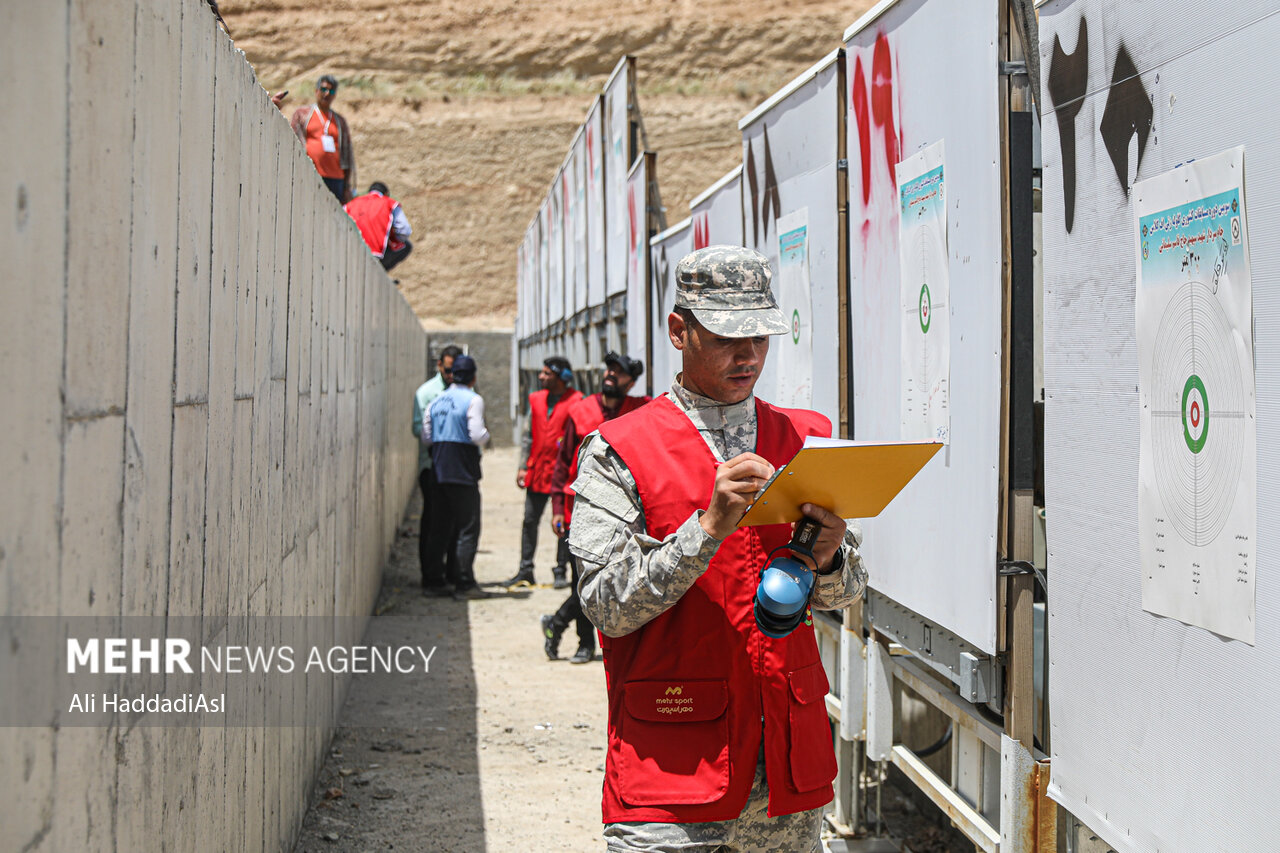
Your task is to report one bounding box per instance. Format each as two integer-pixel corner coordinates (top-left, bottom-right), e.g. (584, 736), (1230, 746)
(0, 3), (68, 850)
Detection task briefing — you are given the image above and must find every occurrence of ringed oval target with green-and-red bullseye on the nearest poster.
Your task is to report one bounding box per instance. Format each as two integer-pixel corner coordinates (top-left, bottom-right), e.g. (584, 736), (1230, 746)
(1151, 282), (1249, 546)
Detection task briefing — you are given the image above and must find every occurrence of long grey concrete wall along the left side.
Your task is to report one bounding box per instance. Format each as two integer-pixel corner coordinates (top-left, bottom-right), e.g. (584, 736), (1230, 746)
(0, 0), (426, 850)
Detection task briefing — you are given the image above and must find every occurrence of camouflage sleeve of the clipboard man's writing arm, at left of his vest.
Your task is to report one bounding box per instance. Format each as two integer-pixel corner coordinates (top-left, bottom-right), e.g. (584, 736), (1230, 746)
(568, 433), (719, 637)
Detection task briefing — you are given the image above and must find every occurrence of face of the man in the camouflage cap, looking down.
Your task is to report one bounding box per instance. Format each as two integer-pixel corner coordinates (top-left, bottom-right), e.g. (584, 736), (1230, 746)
(667, 313), (769, 403)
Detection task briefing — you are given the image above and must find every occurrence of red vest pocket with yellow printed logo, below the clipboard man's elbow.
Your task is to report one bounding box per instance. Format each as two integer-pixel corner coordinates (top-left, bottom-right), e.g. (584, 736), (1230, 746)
(616, 681), (732, 806)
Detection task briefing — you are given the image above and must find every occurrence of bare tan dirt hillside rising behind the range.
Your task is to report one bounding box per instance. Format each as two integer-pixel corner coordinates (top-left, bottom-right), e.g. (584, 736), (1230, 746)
(219, 0), (872, 329)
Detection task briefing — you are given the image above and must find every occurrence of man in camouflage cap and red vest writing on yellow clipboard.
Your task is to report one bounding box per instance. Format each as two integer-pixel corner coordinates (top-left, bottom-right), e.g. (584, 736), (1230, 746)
(570, 246), (867, 853)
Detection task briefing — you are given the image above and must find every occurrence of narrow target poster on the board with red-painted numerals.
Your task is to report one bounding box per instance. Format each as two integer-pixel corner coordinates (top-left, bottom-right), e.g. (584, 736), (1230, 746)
(896, 140), (951, 443)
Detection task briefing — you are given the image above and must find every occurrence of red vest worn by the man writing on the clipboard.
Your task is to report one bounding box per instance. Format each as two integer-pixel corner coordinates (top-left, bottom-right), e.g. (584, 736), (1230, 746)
(600, 397), (836, 824)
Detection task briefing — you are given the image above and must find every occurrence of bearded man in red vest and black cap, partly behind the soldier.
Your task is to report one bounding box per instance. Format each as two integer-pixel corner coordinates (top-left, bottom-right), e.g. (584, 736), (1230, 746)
(541, 352), (649, 663)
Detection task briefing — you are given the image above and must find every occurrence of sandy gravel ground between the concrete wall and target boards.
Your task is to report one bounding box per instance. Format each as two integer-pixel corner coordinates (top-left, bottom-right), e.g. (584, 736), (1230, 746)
(294, 448), (973, 853)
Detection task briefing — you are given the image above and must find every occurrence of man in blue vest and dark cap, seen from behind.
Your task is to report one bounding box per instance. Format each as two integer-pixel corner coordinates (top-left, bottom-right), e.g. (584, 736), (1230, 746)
(422, 355), (489, 601)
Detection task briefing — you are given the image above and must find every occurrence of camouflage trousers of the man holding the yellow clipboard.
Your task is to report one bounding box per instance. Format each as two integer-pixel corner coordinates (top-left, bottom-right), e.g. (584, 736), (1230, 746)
(604, 752), (822, 853)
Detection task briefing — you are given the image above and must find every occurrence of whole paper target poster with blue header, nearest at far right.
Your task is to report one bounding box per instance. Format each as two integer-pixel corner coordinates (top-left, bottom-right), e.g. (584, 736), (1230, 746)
(1134, 149), (1257, 643)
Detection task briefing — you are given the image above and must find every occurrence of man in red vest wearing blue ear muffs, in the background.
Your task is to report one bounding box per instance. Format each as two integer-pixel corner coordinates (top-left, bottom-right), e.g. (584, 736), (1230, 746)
(500, 356), (582, 589)
